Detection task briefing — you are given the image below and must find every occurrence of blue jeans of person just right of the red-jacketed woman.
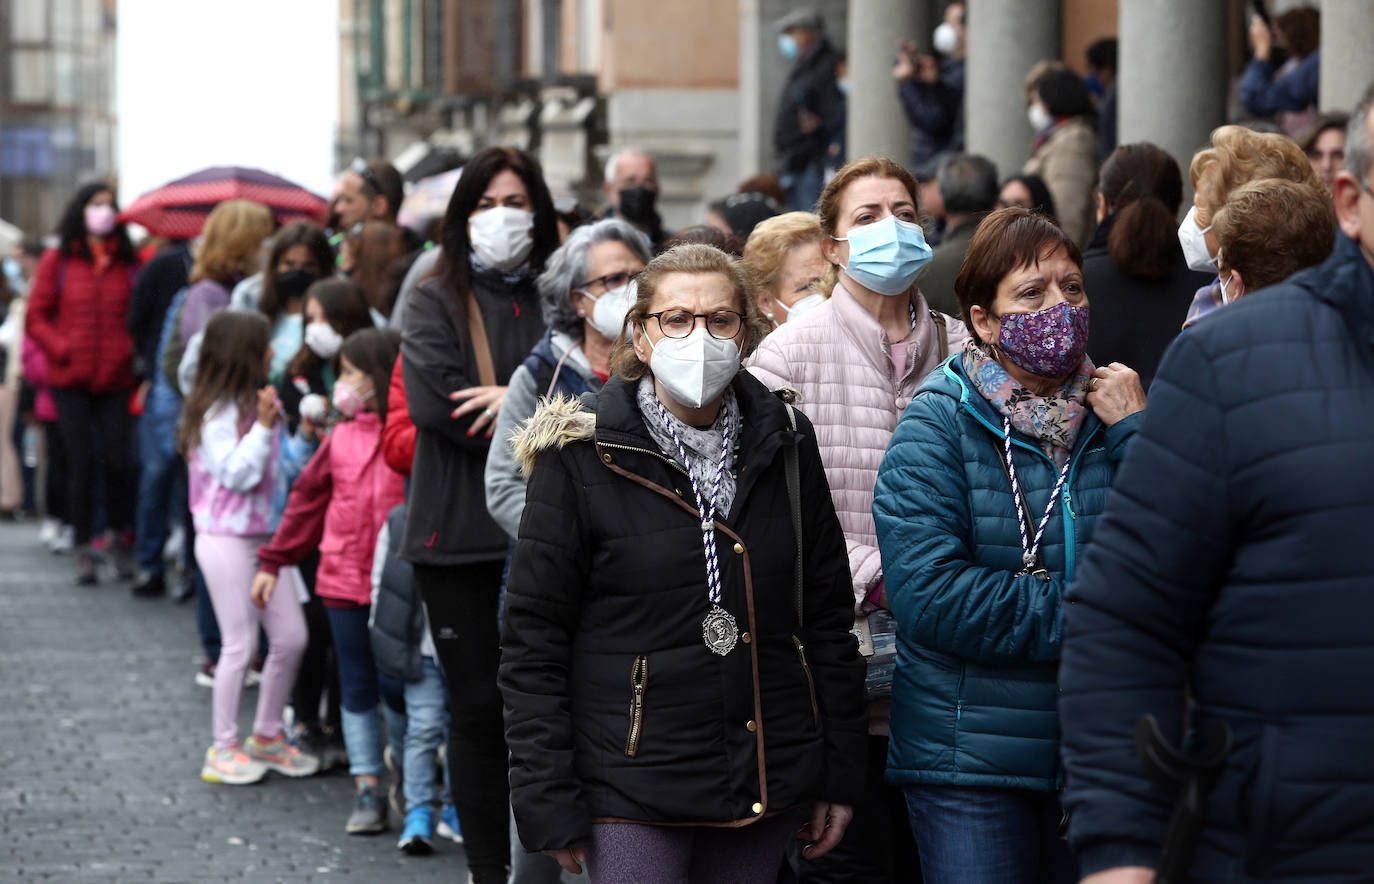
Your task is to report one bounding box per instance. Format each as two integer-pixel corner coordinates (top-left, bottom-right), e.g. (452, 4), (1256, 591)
(135, 373), (183, 575)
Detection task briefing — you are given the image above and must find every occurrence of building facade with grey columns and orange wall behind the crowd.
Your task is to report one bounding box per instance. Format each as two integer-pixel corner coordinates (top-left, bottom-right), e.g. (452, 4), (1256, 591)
(339, 0), (1374, 227)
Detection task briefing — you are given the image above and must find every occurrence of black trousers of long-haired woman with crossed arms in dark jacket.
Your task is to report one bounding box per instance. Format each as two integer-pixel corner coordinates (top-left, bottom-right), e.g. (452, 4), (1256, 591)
(415, 561), (511, 884)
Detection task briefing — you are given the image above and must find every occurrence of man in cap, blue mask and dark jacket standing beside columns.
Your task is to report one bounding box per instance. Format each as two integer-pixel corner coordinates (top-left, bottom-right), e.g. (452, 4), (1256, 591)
(774, 10), (845, 212)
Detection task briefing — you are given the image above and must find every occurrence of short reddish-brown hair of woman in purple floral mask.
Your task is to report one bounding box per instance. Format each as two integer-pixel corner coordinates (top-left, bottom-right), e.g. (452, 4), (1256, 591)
(954, 206), (1083, 344)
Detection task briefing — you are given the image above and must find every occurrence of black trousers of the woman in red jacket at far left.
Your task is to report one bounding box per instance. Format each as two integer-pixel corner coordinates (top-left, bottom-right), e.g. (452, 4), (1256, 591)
(52, 389), (135, 546)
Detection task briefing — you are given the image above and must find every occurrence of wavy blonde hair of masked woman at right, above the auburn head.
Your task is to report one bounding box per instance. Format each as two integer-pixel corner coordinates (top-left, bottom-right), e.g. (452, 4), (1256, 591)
(1189, 125), (1322, 223)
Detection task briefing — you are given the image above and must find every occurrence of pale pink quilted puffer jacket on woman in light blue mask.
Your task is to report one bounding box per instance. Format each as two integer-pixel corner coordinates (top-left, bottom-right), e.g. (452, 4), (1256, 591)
(747, 283), (969, 612)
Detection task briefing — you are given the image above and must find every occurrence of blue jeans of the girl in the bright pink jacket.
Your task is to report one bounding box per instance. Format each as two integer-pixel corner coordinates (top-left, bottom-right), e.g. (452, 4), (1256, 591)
(324, 606), (382, 777)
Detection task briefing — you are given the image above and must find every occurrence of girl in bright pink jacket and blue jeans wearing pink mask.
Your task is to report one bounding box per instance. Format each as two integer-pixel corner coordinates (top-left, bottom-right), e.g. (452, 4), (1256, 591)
(253, 329), (405, 835)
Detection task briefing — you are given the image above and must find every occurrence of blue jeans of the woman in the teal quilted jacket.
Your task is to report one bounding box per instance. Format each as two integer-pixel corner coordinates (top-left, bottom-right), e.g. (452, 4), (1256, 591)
(903, 786), (1079, 884)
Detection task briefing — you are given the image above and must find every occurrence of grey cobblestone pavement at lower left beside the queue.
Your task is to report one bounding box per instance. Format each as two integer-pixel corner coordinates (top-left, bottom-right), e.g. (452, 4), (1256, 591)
(0, 522), (467, 884)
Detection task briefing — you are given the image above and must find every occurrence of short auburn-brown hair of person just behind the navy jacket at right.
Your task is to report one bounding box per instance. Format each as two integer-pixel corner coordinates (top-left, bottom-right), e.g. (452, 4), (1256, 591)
(1212, 179), (1336, 291)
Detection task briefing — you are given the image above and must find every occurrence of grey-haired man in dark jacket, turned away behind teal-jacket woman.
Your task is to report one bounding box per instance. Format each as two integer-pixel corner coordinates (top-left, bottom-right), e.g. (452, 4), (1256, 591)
(916, 154), (998, 318)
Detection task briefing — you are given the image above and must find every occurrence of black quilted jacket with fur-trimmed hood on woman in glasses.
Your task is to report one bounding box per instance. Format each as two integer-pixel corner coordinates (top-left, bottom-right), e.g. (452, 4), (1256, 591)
(500, 373), (866, 850)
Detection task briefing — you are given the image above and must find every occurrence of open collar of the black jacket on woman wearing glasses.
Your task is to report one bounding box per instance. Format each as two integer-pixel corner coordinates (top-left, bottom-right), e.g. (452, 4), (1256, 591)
(596, 371), (801, 511)
